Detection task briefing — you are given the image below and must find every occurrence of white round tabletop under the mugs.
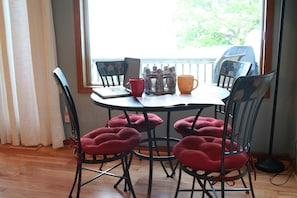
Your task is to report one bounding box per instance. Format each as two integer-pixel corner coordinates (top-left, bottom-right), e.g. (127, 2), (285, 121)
(91, 85), (230, 111)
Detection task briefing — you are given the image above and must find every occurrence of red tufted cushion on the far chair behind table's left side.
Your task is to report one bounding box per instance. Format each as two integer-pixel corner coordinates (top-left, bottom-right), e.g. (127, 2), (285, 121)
(106, 113), (163, 131)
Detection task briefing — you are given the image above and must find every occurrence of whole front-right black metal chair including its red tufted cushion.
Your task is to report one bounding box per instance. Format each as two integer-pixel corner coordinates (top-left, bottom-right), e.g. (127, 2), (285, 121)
(173, 72), (274, 197)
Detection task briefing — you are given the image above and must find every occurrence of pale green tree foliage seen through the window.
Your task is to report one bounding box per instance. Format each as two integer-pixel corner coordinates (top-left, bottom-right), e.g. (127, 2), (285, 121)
(173, 0), (262, 49)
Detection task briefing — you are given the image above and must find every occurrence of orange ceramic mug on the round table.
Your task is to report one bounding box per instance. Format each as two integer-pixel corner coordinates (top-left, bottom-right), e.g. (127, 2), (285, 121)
(177, 75), (198, 94)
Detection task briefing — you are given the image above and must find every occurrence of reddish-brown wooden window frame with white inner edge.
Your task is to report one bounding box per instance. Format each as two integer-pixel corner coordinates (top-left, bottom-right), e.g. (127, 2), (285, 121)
(73, 0), (274, 93)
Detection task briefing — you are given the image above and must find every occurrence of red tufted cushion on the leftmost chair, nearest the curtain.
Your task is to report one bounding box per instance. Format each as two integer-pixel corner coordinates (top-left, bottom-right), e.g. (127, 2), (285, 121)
(81, 127), (141, 155)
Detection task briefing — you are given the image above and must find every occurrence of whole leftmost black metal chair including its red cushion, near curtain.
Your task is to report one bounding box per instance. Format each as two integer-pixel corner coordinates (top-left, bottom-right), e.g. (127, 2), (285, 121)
(53, 67), (141, 197)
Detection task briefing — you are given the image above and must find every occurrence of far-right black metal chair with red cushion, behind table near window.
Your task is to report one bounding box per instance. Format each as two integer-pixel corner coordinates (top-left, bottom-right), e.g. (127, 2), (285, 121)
(174, 60), (251, 137)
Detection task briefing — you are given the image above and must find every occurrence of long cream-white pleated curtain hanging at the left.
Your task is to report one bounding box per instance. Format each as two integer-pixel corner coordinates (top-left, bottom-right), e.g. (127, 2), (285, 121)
(0, 0), (65, 148)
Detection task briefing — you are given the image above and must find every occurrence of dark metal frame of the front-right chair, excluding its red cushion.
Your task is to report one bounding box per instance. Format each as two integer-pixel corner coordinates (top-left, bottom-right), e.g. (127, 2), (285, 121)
(175, 72), (274, 197)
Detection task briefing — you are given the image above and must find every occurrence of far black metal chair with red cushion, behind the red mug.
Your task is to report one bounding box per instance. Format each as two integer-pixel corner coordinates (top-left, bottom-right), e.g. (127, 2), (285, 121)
(96, 59), (176, 181)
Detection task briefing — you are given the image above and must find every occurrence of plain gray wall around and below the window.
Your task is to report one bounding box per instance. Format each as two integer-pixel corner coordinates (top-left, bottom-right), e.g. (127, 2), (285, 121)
(52, 0), (297, 158)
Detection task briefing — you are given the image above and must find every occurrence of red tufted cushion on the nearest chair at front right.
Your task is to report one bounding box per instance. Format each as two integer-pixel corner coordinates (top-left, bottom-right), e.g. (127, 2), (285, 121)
(173, 135), (249, 172)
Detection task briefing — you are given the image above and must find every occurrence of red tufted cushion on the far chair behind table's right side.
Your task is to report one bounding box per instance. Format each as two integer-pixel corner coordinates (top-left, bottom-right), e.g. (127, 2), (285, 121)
(174, 116), (232, 137)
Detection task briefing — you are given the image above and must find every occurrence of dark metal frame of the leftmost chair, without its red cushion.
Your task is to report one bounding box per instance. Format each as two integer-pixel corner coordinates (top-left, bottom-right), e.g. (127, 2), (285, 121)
(53, 67), (136, 198)
